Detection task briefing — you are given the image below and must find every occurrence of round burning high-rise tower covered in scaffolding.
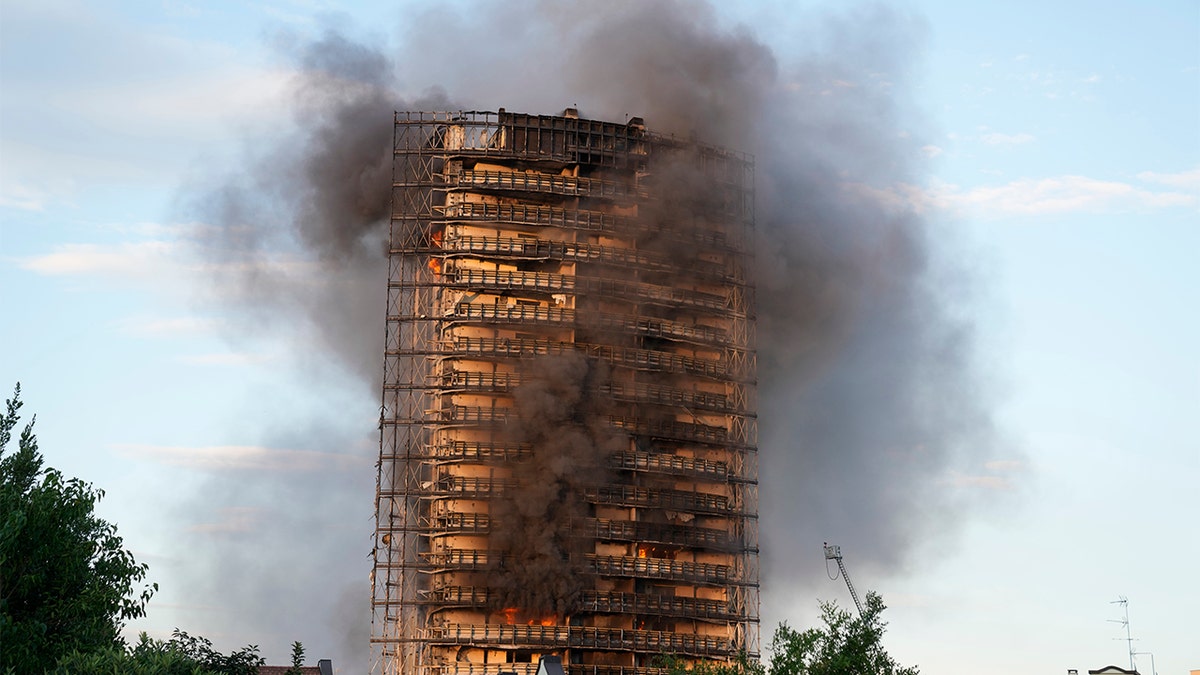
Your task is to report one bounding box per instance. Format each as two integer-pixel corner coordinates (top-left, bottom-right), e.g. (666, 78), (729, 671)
(372, 109), (758, 675)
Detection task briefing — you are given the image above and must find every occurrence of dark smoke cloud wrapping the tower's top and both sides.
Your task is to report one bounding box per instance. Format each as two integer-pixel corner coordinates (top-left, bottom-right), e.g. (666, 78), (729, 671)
(177, 1), (996, 662)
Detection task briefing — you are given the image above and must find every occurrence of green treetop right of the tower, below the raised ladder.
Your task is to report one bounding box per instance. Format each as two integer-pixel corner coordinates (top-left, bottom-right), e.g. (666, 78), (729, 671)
(768, 591), (919, 675)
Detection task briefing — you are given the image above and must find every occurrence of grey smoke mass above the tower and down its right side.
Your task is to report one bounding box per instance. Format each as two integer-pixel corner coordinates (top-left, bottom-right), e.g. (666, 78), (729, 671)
(384, 1), (1002, 597)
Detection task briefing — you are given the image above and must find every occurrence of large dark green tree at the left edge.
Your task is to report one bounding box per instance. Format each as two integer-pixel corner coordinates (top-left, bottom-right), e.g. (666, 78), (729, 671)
(0, 384), (157, 673)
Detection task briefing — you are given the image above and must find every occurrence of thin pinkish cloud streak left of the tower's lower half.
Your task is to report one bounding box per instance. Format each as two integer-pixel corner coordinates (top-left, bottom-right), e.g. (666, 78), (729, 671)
(113, 444), (368, 471)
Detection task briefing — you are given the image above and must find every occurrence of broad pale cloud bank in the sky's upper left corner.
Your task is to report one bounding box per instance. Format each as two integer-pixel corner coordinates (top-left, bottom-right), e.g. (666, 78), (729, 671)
(0, 2), (294, 196)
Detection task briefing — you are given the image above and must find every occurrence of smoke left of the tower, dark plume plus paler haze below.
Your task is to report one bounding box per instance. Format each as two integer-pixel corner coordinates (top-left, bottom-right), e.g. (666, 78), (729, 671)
(171, 28), (450, 673)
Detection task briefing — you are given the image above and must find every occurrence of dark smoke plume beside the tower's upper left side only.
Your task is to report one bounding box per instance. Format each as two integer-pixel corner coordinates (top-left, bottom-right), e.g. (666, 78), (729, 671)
(188, 28), (451, 389)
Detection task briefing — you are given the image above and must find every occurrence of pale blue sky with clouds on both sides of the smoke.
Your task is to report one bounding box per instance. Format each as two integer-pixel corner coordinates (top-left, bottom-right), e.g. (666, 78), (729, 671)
(0, 0), (1200, 675)
